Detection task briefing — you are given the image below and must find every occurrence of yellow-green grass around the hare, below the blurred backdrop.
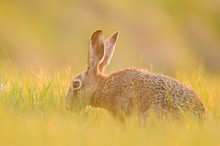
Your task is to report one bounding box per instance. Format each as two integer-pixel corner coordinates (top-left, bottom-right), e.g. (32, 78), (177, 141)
(0, 65), (220, 146)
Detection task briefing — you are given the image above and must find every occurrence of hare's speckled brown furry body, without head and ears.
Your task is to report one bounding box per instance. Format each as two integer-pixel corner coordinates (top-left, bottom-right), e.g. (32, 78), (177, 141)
(90, 68), (206, 119)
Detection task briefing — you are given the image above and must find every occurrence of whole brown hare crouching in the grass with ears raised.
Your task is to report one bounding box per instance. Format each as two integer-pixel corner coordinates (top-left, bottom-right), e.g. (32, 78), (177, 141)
(65, 30), (207, 119)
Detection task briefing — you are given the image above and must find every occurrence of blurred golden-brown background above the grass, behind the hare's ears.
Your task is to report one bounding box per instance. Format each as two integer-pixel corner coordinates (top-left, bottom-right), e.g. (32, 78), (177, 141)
(0, 0), (220, 74)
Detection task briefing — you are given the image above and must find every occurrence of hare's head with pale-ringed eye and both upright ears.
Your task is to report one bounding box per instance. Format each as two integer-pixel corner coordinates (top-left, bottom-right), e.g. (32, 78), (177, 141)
(65, 30), (118, 110)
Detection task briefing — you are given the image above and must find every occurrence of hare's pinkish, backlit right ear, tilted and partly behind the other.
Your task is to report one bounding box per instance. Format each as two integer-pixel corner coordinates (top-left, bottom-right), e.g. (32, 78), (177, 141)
(99, 32), (118, 73)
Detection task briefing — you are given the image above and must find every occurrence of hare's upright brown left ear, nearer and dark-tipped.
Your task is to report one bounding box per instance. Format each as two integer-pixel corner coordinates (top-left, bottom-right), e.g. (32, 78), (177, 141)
(88, 30), (105, 75)
